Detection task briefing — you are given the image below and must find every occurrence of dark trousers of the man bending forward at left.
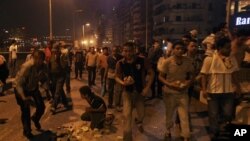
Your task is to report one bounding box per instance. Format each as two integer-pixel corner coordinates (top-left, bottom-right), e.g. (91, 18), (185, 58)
(14, 89), (45, 133)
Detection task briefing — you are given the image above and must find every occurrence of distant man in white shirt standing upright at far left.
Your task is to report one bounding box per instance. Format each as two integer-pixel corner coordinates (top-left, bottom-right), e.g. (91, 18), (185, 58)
(9, 40), (17, 77)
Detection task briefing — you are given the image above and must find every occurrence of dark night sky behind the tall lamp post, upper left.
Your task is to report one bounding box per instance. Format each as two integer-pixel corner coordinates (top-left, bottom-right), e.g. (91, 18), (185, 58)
(0, 0), (118, 36)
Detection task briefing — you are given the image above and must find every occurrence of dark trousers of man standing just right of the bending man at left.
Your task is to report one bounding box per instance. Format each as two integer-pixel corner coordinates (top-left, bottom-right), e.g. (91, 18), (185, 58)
(51, 74), (68, 109)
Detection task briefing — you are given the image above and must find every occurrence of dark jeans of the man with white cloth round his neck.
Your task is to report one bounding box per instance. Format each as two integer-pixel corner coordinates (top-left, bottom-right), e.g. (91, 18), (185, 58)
(208, 93), (234, 135)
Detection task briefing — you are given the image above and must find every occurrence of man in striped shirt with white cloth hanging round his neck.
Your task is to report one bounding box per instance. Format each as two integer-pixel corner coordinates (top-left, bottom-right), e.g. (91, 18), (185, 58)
(201, 37), (240, 140)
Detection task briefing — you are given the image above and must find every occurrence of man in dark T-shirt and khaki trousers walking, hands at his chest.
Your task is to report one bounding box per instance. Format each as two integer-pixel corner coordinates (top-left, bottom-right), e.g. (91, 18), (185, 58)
(115, 43), (154, 141)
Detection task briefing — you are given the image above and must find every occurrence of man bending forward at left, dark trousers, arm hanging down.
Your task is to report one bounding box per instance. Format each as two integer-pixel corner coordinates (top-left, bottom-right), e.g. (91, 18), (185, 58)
(14, 51), (46, 138)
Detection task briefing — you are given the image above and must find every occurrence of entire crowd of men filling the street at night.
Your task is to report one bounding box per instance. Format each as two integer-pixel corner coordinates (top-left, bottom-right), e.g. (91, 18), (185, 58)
(0, 24), (250, 141)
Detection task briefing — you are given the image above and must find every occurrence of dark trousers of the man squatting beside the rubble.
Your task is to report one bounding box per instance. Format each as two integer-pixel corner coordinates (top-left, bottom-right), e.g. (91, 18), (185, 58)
(81, 112), (105, 129)
